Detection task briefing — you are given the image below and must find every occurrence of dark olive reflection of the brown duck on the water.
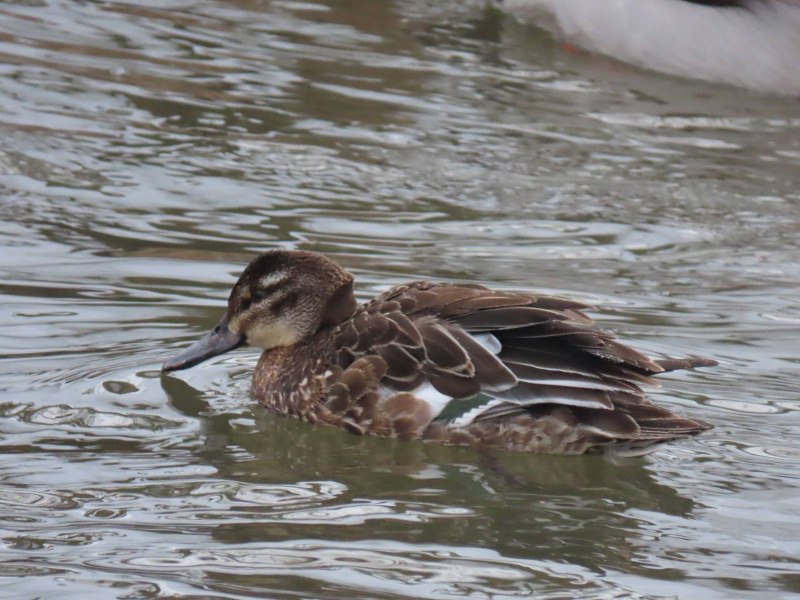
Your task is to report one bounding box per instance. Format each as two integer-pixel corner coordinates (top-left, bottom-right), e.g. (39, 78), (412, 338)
(163, 377), (695, 572)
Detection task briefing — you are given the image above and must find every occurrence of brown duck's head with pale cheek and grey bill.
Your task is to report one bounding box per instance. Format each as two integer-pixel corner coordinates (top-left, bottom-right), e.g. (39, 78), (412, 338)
(161, 250), (356, 371)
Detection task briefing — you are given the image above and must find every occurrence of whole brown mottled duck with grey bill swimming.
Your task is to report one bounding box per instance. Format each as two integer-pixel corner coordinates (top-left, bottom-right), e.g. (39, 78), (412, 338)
(162, 249), (717, 455)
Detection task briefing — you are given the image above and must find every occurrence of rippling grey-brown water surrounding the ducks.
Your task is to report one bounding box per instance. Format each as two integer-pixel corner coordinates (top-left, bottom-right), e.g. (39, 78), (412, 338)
(0, 0), (800, 599)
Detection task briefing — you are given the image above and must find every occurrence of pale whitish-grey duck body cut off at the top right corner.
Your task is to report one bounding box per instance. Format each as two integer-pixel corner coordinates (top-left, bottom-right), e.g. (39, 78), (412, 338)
(499, 0), (800, 96)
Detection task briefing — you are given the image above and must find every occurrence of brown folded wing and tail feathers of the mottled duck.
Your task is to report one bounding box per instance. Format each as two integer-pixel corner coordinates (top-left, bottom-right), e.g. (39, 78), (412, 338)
(331, 282), (716, 440)
